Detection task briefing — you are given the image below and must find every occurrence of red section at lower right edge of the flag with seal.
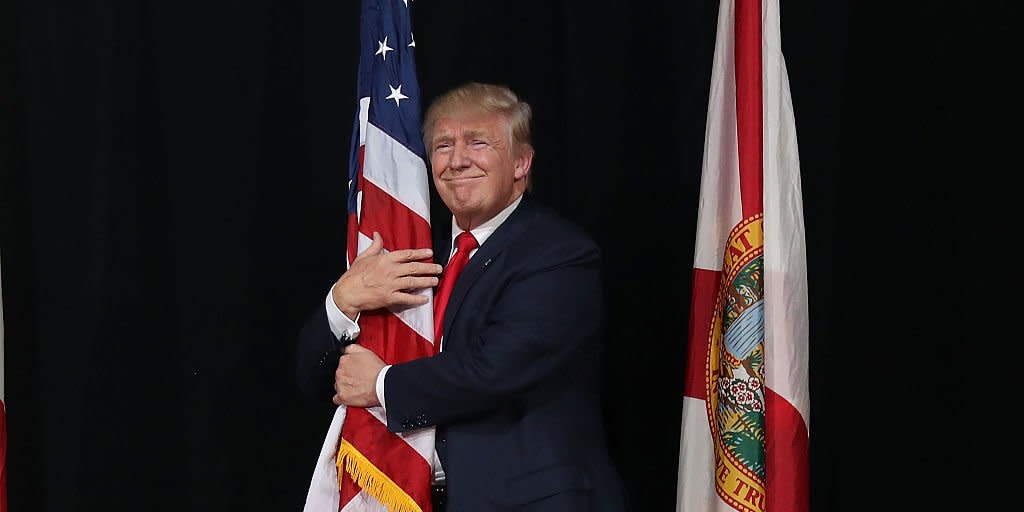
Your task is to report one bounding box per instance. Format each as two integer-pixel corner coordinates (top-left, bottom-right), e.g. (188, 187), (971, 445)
(765, 389), (811, 512)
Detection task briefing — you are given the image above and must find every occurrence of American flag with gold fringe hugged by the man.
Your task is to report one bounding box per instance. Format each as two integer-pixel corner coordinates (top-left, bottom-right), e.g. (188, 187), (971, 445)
(304, 0), (434, 512)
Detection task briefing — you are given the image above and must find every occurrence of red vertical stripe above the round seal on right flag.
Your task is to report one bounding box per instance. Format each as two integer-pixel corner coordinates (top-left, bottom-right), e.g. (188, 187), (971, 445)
(735, 0), (764, 218)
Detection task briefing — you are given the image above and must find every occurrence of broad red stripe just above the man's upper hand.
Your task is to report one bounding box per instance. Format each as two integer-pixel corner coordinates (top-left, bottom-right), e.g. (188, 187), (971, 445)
(359, 179), (431, 251)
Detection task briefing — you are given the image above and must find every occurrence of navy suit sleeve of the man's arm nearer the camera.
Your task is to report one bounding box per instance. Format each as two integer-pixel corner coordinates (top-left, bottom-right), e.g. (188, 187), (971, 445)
(384, 237), (603, 432)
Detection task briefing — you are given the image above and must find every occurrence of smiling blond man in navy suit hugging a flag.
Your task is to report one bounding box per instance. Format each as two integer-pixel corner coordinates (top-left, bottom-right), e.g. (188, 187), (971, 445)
(299, 83), (626, 512)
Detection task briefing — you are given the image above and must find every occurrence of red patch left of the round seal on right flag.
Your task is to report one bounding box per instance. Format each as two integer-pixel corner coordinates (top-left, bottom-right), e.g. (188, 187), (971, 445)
(683, 268), (722, 400)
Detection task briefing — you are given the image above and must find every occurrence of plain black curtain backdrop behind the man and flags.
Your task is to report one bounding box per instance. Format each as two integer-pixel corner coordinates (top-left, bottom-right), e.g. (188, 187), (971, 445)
(0, 0), (1007, 512)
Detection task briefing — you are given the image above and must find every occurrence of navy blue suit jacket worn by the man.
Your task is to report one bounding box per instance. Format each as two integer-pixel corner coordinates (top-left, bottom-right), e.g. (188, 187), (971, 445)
(300, 199), (626, 512)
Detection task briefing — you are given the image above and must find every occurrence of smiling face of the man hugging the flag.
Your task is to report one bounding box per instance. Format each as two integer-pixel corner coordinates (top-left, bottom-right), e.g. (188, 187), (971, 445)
(430, 114), (532, 229)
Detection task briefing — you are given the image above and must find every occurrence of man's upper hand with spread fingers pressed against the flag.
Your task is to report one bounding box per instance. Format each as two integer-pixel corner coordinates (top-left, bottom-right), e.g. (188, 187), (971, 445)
(332, 232), (441, 319)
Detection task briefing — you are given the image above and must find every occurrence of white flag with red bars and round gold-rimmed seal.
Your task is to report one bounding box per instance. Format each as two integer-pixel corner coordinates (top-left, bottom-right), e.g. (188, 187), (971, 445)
(676, 0), (810, 512)
